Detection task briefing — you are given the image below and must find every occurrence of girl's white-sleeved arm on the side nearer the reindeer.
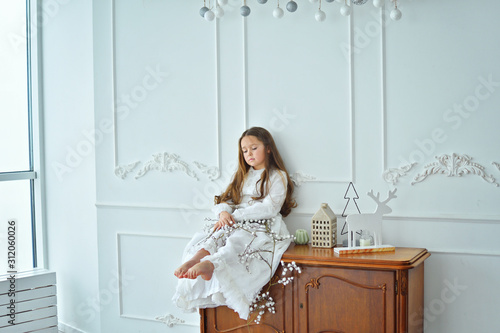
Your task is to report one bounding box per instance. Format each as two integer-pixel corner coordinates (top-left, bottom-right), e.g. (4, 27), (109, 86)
(232, 170), (287, 221)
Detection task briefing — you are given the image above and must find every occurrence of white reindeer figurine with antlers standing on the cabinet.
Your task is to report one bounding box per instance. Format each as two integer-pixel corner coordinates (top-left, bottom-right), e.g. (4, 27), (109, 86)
(346, 189), (397, 247)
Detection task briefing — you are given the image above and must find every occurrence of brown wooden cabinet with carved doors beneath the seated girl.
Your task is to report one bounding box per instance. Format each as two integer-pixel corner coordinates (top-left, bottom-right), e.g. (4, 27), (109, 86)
(200, 244), (430, 333)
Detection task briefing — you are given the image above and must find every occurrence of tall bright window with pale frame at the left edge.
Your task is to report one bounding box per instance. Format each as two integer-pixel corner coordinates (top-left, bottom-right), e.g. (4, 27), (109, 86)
(0, 0), (43, 274)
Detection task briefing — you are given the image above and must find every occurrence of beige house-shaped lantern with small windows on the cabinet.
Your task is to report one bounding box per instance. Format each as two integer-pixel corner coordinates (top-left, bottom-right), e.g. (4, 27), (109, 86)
(311, 203), (337, 247)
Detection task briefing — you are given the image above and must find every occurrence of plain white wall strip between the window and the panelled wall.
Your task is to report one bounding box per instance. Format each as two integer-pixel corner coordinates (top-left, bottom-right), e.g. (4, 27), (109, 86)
(41, 0), (100, 332)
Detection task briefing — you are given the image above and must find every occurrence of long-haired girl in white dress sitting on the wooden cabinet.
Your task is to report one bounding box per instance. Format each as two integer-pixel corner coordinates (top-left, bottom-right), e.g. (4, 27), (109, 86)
(173, 127), (297, 319)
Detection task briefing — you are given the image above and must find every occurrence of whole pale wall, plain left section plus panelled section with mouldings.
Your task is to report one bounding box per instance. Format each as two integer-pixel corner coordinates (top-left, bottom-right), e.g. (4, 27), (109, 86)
(44, 0), (500, 332)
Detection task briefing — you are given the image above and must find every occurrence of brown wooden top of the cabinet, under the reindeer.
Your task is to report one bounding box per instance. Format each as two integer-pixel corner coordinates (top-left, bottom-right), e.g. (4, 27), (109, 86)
(281, 243), (430, 269)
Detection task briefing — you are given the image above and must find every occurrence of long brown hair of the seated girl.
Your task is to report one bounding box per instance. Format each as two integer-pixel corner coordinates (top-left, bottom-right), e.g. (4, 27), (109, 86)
(215, 127), (297, 217)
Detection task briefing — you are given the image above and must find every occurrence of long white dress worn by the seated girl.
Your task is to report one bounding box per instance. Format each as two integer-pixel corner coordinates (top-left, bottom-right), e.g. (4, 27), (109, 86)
(172, 168), (291, 319)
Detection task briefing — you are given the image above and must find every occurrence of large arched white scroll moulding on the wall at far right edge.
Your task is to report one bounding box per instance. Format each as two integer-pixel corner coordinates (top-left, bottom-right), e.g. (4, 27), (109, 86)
(411, 153), (498, 186)
